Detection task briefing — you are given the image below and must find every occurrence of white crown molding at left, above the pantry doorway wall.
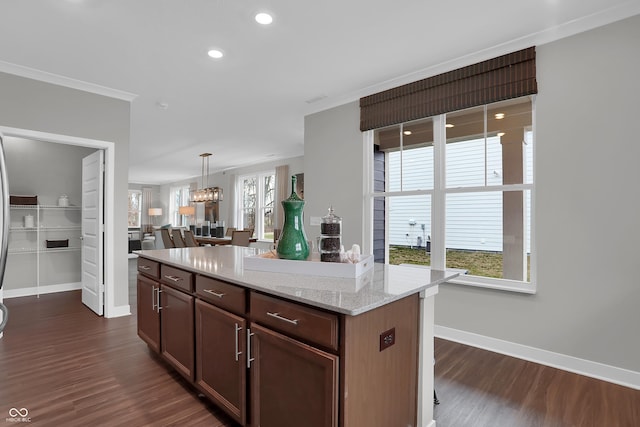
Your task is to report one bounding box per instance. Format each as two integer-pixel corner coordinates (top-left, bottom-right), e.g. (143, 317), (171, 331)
(0, 61), (138, 102)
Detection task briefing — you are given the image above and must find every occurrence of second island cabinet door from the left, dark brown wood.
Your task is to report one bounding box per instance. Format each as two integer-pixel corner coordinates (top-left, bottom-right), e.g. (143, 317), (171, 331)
(160, 285), (194, 381)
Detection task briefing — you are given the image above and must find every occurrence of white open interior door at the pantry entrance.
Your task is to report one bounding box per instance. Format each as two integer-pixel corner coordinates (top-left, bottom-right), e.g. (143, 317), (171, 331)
(82, 150), (104, 316)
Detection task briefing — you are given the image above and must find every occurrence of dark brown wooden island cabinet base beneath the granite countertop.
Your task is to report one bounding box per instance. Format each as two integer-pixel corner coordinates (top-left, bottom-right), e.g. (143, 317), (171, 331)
(138, 258), (420, 427)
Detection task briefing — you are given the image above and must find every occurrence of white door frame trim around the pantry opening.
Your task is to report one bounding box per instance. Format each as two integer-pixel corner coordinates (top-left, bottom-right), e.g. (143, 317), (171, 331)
(0, 126), (115, 317)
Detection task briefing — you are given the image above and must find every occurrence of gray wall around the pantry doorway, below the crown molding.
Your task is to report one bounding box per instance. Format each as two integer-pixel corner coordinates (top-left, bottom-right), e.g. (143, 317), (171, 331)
(0, 73), (131, 307)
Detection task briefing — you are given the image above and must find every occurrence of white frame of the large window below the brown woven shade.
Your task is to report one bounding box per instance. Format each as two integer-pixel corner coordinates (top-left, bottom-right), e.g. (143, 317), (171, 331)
(363, 95), (537, 294)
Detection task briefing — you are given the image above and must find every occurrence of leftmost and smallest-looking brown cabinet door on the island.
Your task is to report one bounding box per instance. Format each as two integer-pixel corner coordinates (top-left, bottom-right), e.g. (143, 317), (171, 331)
(137, 274), (160, 352)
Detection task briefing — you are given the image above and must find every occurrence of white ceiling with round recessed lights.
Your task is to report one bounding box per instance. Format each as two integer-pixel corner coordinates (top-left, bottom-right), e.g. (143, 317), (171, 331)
(0, 0), (640, 184)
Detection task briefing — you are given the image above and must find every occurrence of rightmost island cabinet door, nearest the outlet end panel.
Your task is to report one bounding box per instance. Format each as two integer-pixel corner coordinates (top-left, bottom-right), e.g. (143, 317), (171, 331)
(247, 323), (338, 427)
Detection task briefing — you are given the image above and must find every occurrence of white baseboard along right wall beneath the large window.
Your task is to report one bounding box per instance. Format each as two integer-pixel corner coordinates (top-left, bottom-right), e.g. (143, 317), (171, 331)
(434, 325), (640, 390)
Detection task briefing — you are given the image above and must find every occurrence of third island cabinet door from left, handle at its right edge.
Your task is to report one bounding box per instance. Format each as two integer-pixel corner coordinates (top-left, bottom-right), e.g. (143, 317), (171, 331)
(196, 300), (247, 425)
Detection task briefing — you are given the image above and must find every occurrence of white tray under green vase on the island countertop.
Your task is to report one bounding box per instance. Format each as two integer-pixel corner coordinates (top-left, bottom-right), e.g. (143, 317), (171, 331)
(244, 254), (373, 278)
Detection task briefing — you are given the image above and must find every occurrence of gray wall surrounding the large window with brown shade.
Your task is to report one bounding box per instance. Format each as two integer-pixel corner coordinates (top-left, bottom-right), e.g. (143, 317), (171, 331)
(305, 16), (640, 372)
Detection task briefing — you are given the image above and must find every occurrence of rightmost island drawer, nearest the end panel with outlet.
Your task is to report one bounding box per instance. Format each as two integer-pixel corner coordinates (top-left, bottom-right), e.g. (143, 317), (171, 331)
(250, 292), (338, 351)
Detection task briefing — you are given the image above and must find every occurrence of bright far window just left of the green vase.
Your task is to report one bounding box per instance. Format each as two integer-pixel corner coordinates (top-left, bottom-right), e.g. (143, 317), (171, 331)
(237, 171), (276, 240)
